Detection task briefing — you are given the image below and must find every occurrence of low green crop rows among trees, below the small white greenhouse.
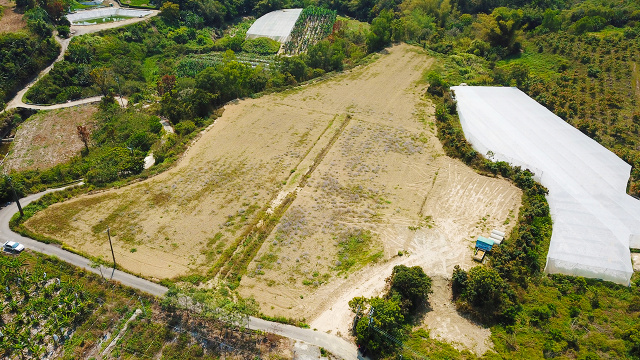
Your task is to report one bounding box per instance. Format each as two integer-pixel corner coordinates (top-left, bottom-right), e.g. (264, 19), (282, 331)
(176, 52), (275, 78)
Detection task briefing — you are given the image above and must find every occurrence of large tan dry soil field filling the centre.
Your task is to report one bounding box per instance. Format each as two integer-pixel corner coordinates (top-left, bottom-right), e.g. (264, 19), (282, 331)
(26, 45), (521, 353)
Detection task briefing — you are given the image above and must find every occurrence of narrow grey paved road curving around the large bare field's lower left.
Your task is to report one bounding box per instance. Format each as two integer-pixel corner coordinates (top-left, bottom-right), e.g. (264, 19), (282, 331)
(0, 185), (363, 360)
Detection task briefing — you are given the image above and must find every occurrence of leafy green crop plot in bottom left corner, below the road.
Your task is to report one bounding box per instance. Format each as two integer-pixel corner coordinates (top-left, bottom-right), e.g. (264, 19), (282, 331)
(0, 255), (97, 359)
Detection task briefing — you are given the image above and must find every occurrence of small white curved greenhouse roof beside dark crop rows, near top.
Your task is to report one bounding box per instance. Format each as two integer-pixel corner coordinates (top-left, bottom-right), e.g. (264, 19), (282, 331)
(247, 9), (302, 44)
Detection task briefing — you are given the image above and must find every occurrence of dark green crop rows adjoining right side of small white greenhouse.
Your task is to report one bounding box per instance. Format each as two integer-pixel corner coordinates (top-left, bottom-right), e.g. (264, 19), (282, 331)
(284, 6), (336, 55)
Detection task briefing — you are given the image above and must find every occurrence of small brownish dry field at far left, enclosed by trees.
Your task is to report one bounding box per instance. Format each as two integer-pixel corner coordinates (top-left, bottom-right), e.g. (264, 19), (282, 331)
(6, 105), (98, 171)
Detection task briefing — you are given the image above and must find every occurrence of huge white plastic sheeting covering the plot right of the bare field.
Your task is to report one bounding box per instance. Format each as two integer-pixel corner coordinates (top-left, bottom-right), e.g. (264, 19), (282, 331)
(452, 86), (640, 285)
